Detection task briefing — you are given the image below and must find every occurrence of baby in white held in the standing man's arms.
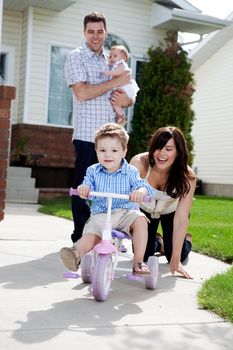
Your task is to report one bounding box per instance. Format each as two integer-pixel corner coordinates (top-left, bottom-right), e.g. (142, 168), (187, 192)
(104, 45), (139, 124)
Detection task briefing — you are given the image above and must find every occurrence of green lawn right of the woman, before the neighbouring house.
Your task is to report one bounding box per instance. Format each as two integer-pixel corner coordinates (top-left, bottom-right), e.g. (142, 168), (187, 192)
(188, 196), (233, 263)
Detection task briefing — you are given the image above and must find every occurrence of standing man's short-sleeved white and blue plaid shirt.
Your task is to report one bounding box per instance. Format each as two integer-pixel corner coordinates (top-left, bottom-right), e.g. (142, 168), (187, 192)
(65, 43), (115, 142)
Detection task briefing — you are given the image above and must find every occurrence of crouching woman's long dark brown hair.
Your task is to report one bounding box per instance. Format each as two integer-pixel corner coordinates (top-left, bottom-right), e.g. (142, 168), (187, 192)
(148, 126), (195, 198)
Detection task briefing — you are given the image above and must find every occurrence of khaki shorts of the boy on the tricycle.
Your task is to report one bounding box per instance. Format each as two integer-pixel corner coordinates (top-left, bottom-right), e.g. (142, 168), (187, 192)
(83, 209), (148, 238)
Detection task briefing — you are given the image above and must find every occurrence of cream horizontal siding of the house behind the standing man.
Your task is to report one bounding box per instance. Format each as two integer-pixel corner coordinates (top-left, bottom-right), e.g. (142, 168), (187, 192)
(3, 0), (164, 124)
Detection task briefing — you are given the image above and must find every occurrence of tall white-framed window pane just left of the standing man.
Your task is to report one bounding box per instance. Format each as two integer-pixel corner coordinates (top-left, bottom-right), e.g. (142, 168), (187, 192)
(48, 46), (72, 126)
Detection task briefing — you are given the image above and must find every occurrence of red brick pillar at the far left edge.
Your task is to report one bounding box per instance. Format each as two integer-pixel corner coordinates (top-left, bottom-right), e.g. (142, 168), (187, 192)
(0, 85), (16, 221)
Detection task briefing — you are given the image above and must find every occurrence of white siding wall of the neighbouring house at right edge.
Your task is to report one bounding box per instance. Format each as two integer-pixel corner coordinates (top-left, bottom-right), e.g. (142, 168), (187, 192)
(193, 40), (233, 184)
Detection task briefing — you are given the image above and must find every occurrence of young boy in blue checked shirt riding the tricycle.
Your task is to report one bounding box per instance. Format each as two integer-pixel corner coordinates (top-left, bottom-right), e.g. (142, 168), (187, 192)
(60, 123), (155, 275)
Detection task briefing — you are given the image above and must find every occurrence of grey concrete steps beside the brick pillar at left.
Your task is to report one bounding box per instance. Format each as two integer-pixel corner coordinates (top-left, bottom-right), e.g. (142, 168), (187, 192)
(6, 167), (39, 203)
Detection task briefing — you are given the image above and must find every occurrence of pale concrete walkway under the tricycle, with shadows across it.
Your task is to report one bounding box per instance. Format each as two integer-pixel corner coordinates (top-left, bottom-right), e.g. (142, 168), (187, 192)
(0, 203), (233, 350)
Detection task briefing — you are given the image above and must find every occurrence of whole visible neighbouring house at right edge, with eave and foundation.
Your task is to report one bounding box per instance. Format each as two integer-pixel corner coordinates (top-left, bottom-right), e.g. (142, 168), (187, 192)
(190, 13), (233, 197)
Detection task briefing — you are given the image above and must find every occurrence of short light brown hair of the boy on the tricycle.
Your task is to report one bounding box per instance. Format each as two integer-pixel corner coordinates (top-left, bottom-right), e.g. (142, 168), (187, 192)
(95, 123), (129, 150)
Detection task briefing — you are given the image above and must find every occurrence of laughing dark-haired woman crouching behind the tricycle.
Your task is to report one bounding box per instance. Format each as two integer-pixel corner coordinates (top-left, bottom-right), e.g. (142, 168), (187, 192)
(130, 126), (196, 278)
